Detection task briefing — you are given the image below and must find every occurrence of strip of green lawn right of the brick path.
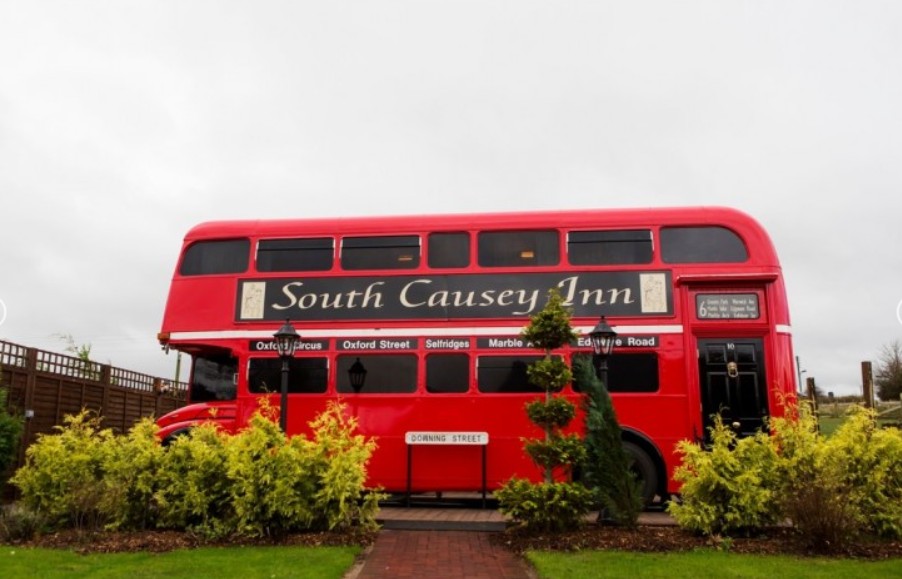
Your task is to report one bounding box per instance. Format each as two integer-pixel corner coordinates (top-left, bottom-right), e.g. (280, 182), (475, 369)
(527, 550), (902, 579)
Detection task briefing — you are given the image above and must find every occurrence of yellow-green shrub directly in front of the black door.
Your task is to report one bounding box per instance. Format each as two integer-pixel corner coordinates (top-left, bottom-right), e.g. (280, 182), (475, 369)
(667, 416), (780, 535)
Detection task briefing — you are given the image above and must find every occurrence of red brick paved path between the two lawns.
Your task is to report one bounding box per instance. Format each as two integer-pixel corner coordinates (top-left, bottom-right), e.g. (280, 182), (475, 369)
(347, 530), (535, 579)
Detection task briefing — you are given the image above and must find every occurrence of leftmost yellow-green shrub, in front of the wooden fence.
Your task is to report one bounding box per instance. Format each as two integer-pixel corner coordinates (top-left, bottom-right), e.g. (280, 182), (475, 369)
(10, 410), (113, 529)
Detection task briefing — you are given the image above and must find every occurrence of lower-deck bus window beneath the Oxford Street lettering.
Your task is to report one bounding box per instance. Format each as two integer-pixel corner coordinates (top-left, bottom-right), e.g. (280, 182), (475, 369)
(335, 354), (417, 394)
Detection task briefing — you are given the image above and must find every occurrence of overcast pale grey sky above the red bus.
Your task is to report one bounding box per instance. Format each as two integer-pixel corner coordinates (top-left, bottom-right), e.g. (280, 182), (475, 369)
(0, 0), (902, 393)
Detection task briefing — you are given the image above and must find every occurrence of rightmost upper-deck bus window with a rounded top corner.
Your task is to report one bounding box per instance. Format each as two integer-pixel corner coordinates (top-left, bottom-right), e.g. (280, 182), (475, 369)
(661, 226), (749, 263)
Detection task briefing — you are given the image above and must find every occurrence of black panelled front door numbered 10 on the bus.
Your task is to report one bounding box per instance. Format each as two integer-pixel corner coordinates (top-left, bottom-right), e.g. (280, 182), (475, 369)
(698, 338), (769, 440)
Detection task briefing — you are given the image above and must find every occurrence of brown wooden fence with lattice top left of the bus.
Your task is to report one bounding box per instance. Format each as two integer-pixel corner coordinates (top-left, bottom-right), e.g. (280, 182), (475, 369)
(0, 341), (187, 467)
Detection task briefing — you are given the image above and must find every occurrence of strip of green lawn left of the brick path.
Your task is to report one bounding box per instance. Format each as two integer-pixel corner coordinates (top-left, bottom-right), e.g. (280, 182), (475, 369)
(0, 545), (361, 579)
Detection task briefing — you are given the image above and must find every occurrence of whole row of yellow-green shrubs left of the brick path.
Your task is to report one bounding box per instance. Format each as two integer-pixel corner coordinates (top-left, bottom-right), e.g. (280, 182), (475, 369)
(13, 404), (382, 538)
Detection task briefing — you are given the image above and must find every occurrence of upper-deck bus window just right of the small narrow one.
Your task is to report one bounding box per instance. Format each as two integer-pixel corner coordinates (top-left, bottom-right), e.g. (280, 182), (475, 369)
(479, 231), (561, 267)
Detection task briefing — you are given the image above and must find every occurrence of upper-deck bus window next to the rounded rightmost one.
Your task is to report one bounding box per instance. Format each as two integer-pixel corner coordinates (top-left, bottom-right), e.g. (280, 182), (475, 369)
(567, 229), (652, 265)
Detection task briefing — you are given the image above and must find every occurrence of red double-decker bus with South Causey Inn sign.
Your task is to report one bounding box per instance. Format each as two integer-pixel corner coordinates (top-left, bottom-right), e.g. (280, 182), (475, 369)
(159, 207), (796, 501)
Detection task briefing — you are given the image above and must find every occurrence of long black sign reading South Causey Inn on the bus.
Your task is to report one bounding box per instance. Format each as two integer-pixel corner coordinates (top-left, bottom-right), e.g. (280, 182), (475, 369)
(235, 271), (673, 321)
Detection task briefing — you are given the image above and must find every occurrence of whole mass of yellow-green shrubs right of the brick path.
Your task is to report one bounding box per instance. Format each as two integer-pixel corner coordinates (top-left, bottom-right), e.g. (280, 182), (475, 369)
(668, 404), (902, 550)
